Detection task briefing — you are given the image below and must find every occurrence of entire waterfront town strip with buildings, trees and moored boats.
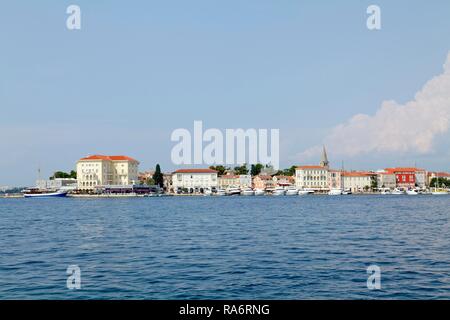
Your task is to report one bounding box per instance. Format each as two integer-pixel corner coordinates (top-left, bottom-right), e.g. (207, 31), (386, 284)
(3, 147), (450, 197)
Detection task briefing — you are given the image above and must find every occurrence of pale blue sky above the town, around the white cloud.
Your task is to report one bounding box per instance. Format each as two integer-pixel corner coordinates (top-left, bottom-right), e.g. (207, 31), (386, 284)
(0, 0), (450, 185)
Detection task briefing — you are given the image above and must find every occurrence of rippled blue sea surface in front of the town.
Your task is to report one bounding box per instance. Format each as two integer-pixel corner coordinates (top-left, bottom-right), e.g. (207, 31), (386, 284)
(0, 196), (450, 299)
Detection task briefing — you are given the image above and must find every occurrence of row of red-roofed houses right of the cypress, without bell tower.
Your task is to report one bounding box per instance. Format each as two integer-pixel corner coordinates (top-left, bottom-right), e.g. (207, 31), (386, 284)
(164, 165), (450, 193)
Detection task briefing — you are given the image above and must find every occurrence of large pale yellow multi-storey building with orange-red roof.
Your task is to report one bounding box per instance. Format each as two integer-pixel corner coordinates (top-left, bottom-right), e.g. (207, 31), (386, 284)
(77, 155), (139, 190)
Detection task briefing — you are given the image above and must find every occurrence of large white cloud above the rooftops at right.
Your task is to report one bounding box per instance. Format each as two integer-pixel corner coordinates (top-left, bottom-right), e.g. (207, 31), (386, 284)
(300, 53), (450, 159)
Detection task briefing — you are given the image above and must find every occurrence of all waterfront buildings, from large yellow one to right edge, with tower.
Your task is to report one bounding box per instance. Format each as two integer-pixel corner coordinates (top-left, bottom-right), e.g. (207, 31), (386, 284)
(68, 152), (450, 193)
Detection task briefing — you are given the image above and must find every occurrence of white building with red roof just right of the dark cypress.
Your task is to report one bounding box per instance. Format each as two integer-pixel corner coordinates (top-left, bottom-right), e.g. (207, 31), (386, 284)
(172, 169), (218, 193)
